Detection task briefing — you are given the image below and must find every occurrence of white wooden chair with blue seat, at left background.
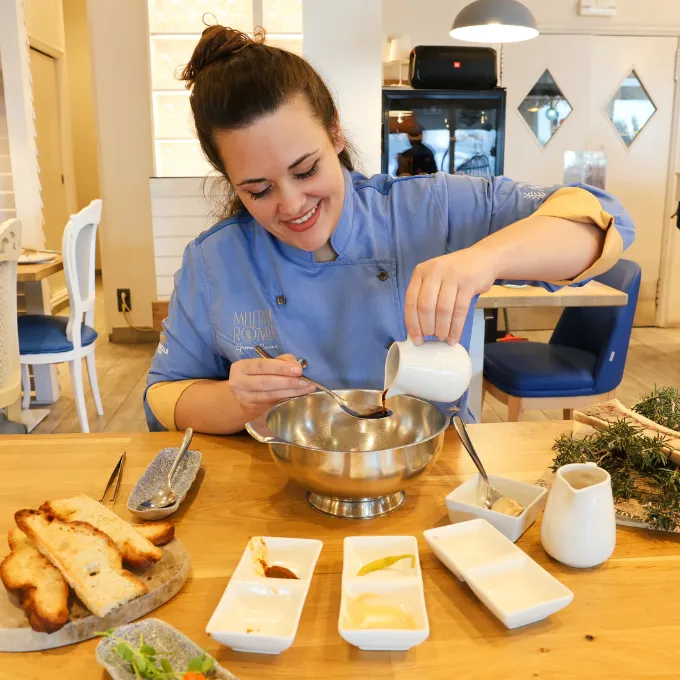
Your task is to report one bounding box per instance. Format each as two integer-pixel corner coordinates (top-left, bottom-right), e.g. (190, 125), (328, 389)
(19, 199), (104, 432)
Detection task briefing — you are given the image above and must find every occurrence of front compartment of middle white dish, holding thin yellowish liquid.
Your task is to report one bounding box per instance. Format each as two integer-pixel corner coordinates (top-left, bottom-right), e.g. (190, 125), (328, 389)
(338, 580), (430, 651)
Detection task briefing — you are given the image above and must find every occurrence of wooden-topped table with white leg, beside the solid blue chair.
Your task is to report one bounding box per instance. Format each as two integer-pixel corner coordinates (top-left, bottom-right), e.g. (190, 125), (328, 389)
(468, 281), (628, 423)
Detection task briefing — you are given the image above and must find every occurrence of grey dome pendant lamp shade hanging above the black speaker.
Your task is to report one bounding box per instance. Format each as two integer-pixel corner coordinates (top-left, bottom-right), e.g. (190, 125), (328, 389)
(449, 0), (538, 43)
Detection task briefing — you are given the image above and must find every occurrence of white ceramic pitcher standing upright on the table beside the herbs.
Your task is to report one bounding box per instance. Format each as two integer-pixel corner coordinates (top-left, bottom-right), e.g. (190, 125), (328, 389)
(541, 463), (616, 568)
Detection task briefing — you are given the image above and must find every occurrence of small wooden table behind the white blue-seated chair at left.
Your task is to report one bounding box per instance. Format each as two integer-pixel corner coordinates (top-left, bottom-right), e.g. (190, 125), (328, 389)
(17, 253), (64, 432)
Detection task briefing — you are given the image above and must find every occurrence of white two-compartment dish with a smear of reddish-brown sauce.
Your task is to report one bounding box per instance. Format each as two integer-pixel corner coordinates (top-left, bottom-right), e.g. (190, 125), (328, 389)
(206, 536), (323, 654)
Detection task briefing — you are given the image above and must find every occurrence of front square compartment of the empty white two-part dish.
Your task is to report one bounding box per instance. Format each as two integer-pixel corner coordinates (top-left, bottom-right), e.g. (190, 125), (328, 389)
(466, 555), (574, 628)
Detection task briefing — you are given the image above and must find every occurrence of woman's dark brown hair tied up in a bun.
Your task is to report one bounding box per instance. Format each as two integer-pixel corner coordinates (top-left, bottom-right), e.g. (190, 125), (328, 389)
(180, 25), (354, 217)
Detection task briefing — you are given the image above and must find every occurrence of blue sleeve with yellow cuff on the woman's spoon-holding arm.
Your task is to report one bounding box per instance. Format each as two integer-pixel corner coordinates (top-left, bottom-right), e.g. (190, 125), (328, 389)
(144, 241), (231, 430)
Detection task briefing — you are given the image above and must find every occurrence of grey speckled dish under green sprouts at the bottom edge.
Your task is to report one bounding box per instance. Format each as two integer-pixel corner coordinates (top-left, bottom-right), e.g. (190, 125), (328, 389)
(97, 619), (237, 680)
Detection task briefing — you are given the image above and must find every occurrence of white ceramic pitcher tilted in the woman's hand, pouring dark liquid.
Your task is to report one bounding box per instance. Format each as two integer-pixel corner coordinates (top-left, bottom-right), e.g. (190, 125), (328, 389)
(385, 339), (472, 402)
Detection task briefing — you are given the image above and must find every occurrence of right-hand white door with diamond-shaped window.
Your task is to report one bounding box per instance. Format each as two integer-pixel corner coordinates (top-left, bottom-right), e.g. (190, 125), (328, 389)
(588, 36), (678, 326)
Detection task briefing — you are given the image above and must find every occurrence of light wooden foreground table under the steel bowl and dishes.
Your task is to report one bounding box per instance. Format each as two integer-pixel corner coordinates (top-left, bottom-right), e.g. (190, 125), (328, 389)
(0, 422), (680, 680)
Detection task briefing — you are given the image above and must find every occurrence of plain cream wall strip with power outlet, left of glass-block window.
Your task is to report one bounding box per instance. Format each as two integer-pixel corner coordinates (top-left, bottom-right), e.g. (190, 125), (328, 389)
(87, 0), (156, 332)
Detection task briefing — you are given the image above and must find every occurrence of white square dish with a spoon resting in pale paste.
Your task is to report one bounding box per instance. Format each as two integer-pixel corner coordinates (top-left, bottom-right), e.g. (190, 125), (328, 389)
(446, 474), (548, 543)
